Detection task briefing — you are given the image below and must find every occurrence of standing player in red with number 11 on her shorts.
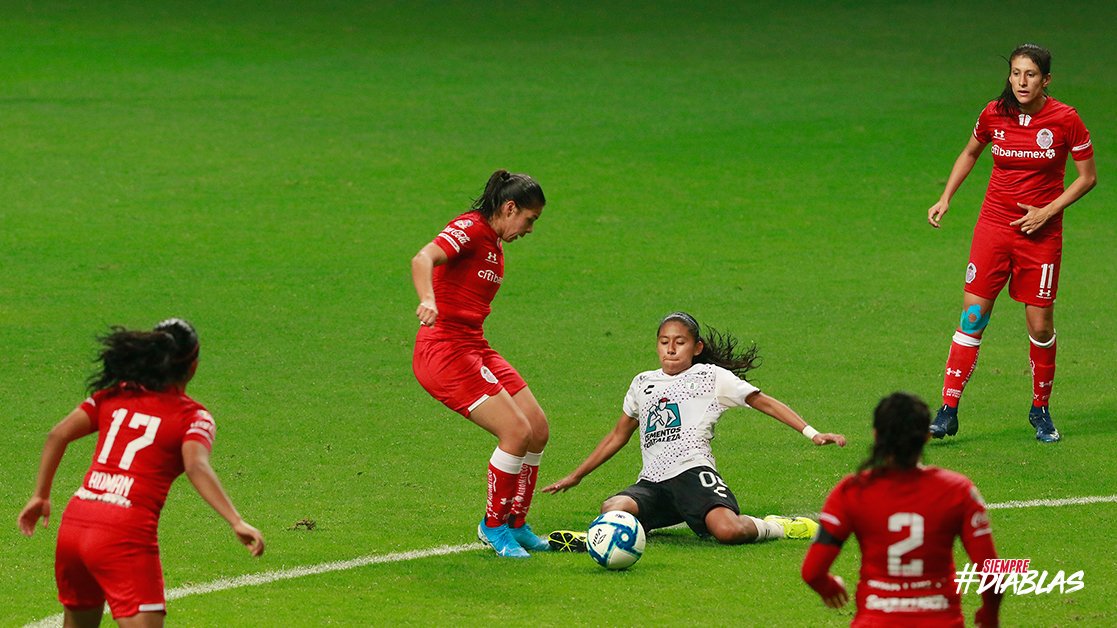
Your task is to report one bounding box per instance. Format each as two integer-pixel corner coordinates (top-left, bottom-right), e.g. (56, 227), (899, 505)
(927, 44), (1097, 443)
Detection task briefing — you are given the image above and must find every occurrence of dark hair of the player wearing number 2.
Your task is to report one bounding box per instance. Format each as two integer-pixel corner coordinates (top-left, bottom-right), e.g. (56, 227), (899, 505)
(857, 392), (930, 472)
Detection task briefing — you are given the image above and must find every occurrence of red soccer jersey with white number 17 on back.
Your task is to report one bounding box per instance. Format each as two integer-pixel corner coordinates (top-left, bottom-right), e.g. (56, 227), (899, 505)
(65, 387), (216, 533)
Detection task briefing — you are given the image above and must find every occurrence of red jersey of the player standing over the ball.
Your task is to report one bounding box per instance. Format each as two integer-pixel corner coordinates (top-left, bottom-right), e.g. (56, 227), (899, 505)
(419, 211), (504, 339)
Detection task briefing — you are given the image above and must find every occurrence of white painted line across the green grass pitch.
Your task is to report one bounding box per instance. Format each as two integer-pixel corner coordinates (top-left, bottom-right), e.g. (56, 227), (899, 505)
(28, 495), (1117, 627)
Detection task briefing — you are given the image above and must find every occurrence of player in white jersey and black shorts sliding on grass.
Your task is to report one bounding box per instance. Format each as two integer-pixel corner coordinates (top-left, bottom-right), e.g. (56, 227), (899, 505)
(543, 312), (846, 544)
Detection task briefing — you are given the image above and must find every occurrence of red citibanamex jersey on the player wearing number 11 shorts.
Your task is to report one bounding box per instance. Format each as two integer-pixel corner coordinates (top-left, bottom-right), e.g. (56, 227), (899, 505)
(974, 97), (1094, 234)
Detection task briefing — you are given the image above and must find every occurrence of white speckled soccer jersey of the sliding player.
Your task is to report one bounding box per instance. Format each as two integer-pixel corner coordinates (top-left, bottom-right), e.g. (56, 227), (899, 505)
(624, 364), (760, 482)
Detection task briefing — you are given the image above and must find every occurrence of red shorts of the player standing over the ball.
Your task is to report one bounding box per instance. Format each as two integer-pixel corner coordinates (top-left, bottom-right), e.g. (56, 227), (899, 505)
(411, 337), (527, 418)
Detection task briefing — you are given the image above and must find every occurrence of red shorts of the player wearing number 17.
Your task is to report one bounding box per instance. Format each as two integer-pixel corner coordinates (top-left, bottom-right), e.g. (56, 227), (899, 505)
(55, 514), (166, 618)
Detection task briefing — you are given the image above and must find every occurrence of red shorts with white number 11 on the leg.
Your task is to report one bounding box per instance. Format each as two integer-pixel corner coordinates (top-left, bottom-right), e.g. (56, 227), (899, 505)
(965, 220), (1062, 307)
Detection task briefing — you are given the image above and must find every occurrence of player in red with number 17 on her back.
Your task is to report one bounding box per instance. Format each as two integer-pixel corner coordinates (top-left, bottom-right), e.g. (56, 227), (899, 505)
(18, 318), (264, 627)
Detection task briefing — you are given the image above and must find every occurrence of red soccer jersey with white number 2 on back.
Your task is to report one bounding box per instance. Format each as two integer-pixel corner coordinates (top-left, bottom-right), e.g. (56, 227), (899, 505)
(819, 467), (996, 620)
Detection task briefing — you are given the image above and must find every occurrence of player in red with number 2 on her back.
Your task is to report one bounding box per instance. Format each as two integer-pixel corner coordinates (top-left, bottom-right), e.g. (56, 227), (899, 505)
(802, 392), (1001, 628)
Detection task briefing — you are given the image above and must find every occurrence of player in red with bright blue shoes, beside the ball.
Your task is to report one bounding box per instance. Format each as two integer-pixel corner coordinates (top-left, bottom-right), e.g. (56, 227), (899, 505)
(411, 170), (548, 558)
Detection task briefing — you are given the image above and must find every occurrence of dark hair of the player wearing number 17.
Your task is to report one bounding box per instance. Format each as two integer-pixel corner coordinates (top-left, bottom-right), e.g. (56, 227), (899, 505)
(88, 318), (201, 392)
